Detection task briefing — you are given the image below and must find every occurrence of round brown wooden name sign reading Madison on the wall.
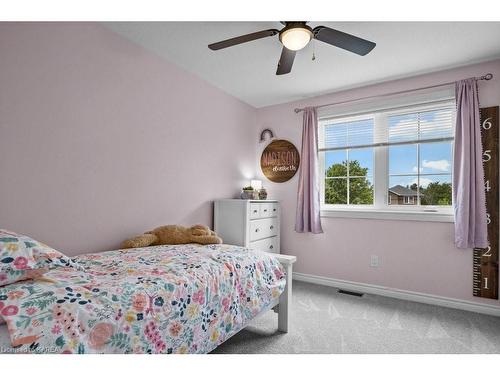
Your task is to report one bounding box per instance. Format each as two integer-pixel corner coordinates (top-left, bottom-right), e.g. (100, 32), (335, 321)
(260, 139), (300, 182)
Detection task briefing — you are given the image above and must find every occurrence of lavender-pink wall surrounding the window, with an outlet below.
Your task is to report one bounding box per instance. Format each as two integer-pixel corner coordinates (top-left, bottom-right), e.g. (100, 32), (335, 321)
(257, 61), (500, 306)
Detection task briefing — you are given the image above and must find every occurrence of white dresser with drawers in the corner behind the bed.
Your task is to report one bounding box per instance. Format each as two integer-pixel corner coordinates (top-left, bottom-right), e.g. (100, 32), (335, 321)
(214, 199), (280, 254)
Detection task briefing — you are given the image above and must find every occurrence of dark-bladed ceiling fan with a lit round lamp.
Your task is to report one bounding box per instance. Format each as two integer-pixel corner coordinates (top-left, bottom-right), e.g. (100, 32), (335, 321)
(208, 21), (376, 75)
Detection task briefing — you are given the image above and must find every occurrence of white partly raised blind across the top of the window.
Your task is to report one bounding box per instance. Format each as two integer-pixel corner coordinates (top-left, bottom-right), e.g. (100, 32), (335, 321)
(319, 102), (455, 151)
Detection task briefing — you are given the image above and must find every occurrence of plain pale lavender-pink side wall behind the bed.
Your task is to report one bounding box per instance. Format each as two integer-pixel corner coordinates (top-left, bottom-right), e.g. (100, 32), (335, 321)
(0, 23), (255, 255)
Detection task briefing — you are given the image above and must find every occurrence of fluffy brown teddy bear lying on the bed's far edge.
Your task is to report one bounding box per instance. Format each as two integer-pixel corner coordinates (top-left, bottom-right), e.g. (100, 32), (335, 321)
(122, 224), (222, 249)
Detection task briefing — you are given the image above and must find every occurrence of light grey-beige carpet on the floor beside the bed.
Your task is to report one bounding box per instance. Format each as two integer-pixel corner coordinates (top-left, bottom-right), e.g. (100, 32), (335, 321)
(213, 281), (500, 354)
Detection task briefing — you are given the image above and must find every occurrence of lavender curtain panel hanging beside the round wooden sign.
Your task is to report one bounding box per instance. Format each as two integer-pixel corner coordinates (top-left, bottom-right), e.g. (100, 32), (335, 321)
(295, 107), (323, 233)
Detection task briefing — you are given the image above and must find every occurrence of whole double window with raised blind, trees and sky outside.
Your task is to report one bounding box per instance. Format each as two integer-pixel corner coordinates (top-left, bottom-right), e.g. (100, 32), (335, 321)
(319, 100), (455, 222)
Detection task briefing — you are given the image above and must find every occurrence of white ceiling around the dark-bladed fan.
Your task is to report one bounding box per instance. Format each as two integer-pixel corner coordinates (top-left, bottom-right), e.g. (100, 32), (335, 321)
(105, 22), (500, 107)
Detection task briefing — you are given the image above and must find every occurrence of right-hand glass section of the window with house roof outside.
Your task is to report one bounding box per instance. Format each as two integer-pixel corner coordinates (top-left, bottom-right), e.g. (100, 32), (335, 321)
(387, 107), (454, 206)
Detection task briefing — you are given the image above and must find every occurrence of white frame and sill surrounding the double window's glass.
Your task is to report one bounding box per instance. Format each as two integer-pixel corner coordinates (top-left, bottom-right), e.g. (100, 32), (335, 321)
(318, 100), (455, 222)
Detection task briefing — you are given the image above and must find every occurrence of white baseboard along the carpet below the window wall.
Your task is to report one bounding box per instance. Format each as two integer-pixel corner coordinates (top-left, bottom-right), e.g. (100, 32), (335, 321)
(293, 272), (500, 316)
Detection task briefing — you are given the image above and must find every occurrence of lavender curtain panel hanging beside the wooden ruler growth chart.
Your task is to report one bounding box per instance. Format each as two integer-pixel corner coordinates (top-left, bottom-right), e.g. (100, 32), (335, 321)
(453, 78), (488, 249)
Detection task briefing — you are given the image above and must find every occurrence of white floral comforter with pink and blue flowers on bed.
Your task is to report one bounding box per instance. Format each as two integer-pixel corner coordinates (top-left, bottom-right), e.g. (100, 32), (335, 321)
(0, 245), (285, 353)
